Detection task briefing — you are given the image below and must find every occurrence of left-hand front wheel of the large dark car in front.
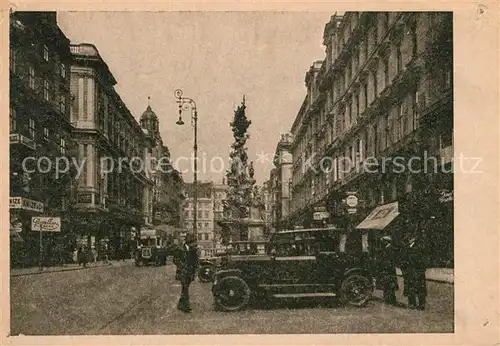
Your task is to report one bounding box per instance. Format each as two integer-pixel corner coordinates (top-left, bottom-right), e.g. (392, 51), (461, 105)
(213, 276), (251, 311)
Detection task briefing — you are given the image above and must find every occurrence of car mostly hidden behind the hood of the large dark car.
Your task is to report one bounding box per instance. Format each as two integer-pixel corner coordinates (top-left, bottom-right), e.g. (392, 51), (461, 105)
(198, 241), (269, 282)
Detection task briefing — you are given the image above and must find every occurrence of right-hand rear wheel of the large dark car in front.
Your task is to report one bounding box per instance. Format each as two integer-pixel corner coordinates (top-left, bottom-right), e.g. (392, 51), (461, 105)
(340, 274), (373, 307)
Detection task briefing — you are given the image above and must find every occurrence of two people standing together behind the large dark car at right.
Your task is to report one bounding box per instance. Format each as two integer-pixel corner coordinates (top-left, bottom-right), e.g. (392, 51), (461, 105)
(375, 218), (427, 310)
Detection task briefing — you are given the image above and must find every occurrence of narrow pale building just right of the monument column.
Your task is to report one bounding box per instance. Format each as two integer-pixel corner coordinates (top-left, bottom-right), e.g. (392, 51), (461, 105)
(272, 133), (293, 230)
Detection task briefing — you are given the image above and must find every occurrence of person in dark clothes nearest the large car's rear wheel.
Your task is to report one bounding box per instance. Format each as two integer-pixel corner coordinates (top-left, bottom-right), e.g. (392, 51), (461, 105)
(377, 237), (399, 305)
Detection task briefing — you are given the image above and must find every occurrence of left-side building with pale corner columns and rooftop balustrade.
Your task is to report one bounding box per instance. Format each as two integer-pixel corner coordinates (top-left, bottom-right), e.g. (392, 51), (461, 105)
(71, 43), (154, 255)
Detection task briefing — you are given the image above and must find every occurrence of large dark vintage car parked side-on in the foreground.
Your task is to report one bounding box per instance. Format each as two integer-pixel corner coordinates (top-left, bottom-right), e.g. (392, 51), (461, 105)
(212, 228), (374, 311)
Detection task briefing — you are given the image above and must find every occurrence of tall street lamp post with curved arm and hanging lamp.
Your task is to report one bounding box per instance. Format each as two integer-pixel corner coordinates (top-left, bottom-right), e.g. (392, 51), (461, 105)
(174, 89), (198, 237)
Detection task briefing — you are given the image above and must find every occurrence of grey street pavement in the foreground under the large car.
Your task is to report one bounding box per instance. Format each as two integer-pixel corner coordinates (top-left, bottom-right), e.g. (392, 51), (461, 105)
(11, 262), (453, 335)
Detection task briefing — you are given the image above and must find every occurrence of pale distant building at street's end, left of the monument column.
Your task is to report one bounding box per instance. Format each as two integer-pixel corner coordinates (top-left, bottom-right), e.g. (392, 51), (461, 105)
(184, 182), (215, 254)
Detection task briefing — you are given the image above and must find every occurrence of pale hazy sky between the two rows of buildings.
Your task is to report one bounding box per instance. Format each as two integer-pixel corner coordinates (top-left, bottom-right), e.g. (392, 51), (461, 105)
(58, 12), (333, 184)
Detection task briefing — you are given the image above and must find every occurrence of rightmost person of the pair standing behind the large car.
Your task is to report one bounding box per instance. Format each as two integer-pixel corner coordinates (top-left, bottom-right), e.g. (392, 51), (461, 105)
(401, 237), (427, 310)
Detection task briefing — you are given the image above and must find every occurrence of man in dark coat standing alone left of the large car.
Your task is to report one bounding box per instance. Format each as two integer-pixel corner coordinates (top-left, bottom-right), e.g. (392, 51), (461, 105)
(174, 234), (198, 312)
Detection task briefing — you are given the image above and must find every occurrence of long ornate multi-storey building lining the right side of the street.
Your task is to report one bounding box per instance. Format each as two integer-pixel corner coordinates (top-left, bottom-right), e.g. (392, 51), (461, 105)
(292, 12), (453, 264)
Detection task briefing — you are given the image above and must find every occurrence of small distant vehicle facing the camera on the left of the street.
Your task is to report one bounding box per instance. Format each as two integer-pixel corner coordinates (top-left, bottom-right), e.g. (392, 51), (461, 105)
(135, 229), (169, 267)
